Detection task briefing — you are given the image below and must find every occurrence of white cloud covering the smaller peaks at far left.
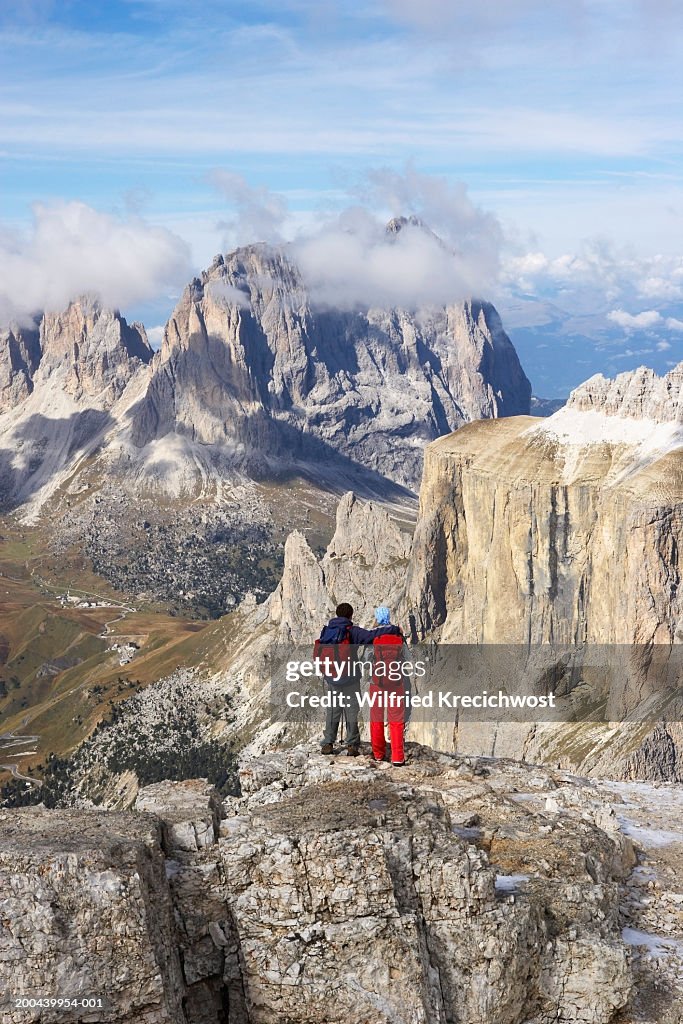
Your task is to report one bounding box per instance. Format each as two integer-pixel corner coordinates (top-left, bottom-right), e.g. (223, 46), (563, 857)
(0, 202), (189, 324)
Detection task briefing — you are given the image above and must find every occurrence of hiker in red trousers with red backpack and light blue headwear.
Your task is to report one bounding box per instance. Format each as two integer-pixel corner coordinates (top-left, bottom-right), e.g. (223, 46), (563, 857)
(370, 605), (407, 768)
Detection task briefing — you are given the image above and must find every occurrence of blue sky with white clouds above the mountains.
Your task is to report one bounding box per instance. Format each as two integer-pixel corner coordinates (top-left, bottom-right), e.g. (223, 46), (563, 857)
(0, 0), (683, 397)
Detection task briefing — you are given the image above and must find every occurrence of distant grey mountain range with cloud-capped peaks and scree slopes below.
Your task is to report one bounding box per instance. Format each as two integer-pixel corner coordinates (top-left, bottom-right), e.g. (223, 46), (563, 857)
(0, 232), (530, 614)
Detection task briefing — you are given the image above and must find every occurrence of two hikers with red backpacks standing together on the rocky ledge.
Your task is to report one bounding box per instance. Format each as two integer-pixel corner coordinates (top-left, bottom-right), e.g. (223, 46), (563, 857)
(315, 602), (405, 768)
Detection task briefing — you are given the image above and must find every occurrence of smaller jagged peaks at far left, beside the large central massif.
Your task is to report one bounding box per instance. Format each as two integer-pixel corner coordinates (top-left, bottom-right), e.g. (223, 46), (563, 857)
(0, 299), (153, 516)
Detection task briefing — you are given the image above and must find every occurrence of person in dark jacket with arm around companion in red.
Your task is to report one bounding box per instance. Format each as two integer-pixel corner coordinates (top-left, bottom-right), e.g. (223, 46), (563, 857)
(318, 601), (400, 758)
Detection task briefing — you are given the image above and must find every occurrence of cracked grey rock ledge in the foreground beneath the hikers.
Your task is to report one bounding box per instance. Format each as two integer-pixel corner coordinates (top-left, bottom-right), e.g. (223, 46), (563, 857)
(0, 746), (683, 1024)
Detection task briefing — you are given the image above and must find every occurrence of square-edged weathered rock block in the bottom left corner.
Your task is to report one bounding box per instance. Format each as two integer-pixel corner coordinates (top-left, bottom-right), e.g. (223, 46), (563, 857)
(0, 808), (183, 1024)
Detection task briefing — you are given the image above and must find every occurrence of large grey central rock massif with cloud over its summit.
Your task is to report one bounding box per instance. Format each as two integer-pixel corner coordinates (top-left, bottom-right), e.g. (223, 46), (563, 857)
(133, 245), (530, 486)
